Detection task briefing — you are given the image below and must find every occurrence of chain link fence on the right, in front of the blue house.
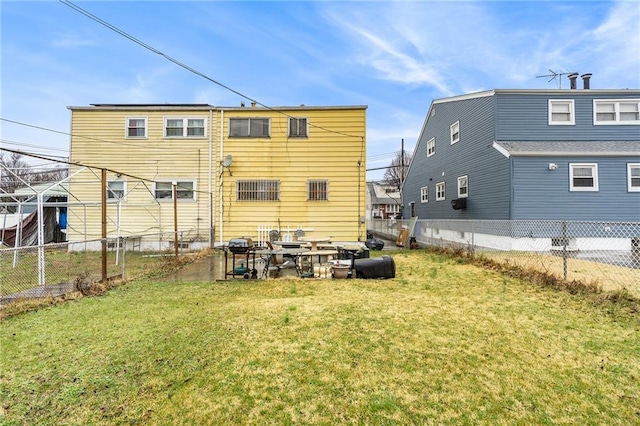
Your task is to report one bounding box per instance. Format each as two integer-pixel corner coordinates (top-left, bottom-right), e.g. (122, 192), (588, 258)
(368, 220), (640, 295)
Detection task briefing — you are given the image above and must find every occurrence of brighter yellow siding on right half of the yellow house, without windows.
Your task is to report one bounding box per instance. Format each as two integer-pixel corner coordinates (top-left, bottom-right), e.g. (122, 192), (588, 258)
(223, 109), (366, 241)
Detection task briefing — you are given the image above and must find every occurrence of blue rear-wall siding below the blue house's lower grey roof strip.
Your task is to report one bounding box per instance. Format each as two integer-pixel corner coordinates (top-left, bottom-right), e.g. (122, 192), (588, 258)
(513, 156), (640, 222)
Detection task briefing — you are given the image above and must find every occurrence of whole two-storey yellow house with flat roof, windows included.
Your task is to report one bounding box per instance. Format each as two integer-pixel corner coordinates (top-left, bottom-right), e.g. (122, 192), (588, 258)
(68, 104), (366, 249)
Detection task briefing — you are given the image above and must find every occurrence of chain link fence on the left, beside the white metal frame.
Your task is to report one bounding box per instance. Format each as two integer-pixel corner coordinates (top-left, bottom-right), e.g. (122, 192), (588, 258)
(0, 233), (202, 305)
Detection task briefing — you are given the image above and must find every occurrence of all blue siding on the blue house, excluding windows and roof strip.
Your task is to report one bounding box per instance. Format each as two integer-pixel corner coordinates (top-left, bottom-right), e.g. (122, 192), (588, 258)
(403, 90), (640, 221)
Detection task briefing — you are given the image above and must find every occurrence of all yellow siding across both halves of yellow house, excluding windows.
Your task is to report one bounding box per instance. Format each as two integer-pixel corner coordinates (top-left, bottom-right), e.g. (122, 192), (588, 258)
(69, 107), (366, 248)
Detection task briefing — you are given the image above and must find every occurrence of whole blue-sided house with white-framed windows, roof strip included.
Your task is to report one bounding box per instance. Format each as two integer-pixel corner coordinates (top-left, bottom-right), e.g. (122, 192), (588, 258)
(402, 85), (640, 222)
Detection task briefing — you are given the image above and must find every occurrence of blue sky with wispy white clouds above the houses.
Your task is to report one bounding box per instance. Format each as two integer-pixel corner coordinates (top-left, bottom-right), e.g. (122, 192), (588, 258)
(0, 0), (640, 180)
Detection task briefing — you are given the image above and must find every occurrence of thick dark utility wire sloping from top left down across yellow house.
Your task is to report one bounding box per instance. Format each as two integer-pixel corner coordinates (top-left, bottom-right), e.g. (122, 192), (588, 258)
(59, 0), (361, 137)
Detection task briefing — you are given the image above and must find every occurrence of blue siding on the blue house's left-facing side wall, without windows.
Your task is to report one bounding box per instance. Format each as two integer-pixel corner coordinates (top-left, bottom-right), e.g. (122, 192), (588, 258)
(403, 96), (510, 219)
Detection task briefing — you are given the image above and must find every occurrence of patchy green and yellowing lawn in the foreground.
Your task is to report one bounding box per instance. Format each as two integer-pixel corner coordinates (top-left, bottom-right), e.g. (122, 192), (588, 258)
(0, 251), (640, 425)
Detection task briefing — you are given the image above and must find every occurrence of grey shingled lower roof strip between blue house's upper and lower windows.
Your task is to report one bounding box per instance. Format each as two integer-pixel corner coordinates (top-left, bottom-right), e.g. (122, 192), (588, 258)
(493, 141), (640, 157)
